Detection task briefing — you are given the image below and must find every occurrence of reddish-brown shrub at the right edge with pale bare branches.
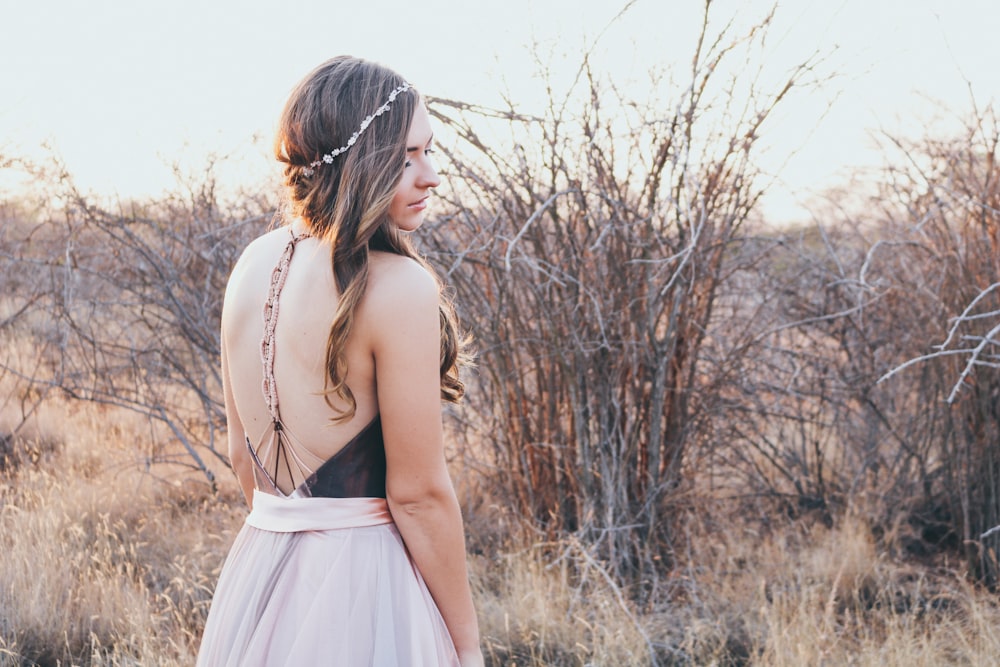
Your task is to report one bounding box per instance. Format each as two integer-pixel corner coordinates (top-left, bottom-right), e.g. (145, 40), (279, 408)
(877, 111), (1000, 585)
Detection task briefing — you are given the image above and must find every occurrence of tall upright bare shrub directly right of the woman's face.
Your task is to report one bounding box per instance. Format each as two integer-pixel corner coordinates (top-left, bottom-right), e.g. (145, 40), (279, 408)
(425, 3), (807, 592)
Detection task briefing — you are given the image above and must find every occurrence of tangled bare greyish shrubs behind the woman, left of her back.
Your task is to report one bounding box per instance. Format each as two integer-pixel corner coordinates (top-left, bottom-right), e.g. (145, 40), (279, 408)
(0, 161), (273, 488)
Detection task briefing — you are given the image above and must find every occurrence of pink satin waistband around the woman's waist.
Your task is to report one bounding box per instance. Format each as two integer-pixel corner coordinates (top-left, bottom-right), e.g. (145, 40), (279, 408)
(246, 489), (392, 533)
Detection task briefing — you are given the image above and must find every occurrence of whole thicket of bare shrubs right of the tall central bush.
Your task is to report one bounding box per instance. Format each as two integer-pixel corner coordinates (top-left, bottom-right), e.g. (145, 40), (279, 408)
(713, 105), (1000, 584)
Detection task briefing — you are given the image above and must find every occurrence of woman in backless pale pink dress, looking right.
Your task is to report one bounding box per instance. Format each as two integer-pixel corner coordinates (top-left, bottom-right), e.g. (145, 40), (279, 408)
(198, 57), (483, 667)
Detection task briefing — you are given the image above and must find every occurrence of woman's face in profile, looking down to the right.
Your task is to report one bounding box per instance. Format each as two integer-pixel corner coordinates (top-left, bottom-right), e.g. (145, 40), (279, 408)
(389, 103), (441, 232)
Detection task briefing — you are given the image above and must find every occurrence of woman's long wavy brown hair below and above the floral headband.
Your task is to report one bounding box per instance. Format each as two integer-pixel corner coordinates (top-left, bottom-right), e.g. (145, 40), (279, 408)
(274, 56), (465, 421)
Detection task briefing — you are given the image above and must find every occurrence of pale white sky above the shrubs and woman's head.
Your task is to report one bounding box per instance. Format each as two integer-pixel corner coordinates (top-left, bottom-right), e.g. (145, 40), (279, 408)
(0, 0), (1000, 224)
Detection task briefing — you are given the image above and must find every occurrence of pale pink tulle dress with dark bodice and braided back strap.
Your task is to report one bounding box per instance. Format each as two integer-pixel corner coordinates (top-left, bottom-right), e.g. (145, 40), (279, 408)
(198, 236), (458, 667)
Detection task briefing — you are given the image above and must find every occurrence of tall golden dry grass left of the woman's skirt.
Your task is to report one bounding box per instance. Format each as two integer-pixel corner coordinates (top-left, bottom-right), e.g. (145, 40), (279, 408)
(0, 388), (239, 665)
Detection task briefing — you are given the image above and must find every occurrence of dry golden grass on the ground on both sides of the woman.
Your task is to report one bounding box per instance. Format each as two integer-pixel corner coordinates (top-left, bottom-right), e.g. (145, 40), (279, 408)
(0, 394), (1000, 667)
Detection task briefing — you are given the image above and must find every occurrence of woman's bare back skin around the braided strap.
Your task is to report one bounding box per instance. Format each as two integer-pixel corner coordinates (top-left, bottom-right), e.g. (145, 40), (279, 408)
(223, 227), (378, 492)
